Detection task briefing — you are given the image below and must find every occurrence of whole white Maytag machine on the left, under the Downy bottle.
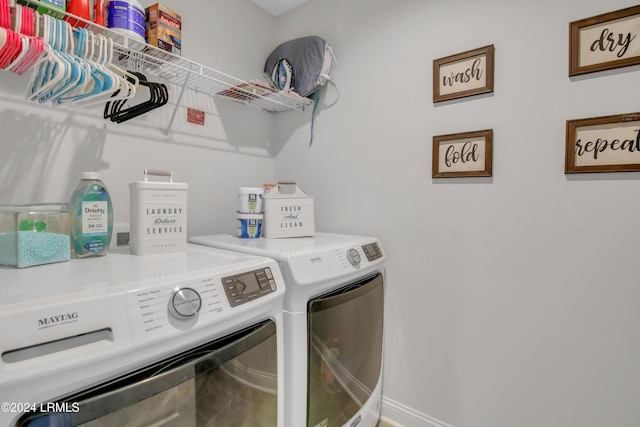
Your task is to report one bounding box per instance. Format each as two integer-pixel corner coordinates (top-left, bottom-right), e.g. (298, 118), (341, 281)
(0, 245), (285, 427)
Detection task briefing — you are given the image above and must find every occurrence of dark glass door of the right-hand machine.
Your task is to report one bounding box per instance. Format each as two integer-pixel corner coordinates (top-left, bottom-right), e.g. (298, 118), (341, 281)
(307, 274), (384, 427)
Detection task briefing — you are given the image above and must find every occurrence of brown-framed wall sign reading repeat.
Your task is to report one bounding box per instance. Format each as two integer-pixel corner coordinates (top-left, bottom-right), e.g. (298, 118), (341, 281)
(564, 113), (640, 173)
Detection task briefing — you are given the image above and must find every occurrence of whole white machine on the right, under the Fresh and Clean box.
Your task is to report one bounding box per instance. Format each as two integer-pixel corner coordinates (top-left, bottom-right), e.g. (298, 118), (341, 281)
(190, 233), (385, 427)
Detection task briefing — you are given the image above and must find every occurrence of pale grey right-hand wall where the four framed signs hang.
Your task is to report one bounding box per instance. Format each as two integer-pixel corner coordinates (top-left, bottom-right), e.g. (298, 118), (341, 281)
(276, 0), (640, 427)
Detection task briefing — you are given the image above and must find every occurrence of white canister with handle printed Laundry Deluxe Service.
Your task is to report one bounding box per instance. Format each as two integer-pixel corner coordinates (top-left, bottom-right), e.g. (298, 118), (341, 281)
(129, 169), (189, 255)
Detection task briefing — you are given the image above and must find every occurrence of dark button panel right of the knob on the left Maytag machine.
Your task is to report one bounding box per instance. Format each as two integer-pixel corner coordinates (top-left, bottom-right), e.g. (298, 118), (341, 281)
(222, 267), (276, 307)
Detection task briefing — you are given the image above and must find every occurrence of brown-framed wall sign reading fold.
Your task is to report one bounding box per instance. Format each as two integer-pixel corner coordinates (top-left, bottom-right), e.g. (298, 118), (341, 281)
(431, 129), (493, 178)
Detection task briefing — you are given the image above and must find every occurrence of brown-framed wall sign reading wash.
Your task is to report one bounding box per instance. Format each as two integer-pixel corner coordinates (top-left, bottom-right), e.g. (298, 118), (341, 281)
(433, 45), (495, 102)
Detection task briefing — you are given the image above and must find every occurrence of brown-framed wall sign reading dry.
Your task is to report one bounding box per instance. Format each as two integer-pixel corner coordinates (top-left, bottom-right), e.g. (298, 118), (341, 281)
(569, 6), (640, 76)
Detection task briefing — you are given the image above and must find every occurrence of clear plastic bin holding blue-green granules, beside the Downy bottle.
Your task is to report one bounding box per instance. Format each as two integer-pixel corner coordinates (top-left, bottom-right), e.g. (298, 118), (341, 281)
(0, 203), (71, 268)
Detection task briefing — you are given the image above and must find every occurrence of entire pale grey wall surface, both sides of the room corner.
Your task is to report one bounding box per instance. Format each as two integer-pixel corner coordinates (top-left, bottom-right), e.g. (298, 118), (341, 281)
(0, 0), (640, 427)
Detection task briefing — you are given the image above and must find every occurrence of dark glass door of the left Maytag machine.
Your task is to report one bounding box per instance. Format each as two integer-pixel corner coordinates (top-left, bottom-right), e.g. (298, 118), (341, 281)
(17, 320), (277, 427)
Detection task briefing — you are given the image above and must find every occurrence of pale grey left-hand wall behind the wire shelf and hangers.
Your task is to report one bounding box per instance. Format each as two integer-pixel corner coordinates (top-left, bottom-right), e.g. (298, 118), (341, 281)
(0, 0), (275, 235)
